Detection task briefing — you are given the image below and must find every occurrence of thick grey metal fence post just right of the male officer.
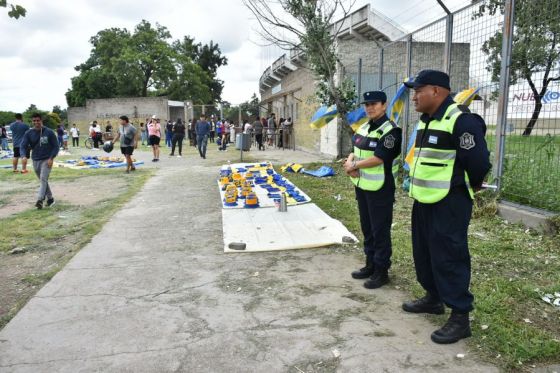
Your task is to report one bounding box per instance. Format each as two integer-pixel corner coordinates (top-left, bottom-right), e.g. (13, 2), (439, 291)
(493, 0), (515, 191)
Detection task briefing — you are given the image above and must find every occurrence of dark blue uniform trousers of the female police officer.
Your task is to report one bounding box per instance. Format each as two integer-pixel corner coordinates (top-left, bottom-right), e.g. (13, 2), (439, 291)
(355, 188), (393, 269)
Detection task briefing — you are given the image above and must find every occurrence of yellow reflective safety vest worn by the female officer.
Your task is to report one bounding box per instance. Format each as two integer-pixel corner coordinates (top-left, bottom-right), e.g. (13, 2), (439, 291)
(350, 120), (399, 191)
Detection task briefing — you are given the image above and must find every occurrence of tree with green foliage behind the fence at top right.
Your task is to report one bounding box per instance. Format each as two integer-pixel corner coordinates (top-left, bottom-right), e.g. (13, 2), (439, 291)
(475, 0), (560, 136)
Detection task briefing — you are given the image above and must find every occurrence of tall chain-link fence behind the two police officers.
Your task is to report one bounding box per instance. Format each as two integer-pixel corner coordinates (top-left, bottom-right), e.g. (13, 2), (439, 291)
(353, 0), (560, 212)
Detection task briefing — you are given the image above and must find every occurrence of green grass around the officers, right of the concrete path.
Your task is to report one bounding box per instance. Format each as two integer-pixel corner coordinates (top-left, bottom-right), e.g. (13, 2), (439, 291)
(288, 164), (560, 370)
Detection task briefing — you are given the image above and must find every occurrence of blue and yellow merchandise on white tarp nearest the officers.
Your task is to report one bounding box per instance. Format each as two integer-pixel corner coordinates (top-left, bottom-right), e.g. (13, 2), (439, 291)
(218, 162), (311, 209)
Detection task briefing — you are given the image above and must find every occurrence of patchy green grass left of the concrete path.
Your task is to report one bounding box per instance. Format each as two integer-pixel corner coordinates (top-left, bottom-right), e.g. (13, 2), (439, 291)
(0, 168), (153, 329)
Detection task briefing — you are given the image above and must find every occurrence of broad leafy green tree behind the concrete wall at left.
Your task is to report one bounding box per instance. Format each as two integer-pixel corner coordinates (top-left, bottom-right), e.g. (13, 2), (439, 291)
(66, 20), (227, 106)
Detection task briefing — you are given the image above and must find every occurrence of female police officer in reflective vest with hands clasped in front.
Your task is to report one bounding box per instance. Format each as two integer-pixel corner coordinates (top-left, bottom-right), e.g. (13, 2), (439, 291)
(344, 91), (402, 289)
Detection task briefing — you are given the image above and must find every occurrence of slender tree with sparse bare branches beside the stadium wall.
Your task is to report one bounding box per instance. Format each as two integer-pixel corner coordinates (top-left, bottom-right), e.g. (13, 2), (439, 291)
(243, 0), (356, 157)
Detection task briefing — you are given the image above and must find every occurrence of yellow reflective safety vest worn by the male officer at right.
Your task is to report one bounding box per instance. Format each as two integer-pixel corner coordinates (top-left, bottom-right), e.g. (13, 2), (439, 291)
(409, 104), (474, 203)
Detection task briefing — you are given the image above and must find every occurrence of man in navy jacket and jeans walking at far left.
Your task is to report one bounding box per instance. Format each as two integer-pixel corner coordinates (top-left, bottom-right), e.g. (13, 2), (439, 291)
(20, 113), (59, 210)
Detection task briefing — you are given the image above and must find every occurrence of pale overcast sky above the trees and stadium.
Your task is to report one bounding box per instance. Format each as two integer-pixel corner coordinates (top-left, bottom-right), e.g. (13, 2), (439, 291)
(0, 0), (470, 111)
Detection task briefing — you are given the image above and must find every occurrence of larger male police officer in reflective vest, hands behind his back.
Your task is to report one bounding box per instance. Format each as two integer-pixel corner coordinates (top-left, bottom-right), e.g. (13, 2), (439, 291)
(402, 70), (491, 343)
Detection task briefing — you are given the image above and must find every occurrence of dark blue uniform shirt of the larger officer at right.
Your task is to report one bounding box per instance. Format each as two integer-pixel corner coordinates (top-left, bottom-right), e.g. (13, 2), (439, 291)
(420, 96), (492, 189)
